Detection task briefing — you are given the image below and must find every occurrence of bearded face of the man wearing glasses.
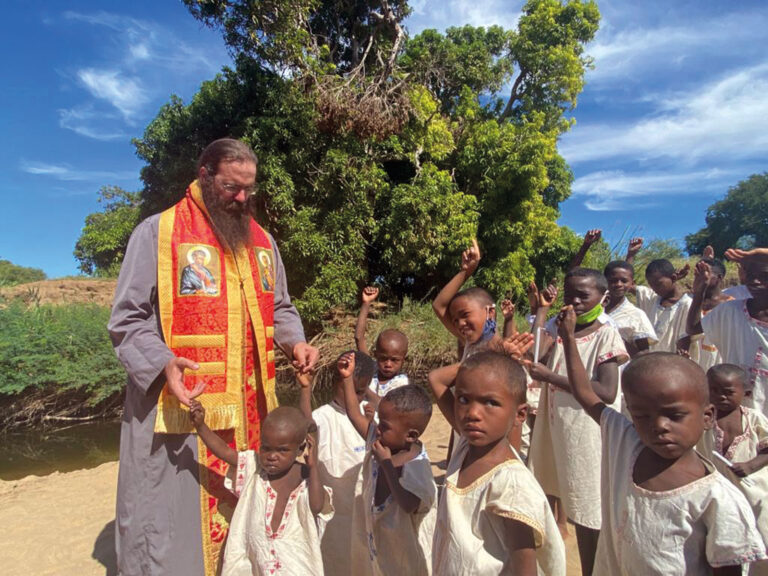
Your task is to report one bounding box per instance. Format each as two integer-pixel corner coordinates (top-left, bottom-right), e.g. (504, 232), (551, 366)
(199, 161), (256, 249)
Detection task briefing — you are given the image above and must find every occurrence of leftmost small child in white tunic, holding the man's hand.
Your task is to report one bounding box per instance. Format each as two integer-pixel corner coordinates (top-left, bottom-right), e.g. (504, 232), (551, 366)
(190, 400), (333, 576)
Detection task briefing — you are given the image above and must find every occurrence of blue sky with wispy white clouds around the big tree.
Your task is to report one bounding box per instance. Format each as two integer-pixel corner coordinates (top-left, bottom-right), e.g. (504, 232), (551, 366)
(0, 0), (768, 277)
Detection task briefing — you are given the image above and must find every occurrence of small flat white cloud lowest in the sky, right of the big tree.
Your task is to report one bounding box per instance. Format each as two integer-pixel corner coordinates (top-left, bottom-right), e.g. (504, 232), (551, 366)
(571, 168), (741, 211)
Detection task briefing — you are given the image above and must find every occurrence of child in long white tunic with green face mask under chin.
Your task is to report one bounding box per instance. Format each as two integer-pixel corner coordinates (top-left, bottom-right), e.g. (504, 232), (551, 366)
(528, 268), (628, 575)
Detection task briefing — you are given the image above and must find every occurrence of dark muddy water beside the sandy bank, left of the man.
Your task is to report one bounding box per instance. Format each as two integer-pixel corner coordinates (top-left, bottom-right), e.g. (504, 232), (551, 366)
(0, 421), (120, 480)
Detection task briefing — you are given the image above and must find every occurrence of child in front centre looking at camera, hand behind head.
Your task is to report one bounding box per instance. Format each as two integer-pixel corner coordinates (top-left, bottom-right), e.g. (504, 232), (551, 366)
(429, 351), (565, 576)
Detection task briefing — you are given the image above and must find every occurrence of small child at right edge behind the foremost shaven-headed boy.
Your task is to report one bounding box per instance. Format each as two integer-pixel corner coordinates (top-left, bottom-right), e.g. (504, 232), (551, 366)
(697, 364), (768, 576)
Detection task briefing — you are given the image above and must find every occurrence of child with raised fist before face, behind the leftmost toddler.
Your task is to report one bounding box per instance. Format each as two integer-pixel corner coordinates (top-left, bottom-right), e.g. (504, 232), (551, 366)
(298, 351), (376, 576)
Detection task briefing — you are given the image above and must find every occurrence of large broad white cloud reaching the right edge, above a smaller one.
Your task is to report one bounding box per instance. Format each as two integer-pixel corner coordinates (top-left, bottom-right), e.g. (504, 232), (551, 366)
(560, 63), (768, 164)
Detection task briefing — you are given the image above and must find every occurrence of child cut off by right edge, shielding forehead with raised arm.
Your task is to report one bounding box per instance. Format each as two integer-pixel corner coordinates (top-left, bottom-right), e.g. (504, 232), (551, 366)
(689, 248), (768, 415)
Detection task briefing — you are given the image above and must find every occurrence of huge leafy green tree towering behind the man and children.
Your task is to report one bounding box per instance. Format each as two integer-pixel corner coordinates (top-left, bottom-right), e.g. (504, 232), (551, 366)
(81, 0), (599, 320)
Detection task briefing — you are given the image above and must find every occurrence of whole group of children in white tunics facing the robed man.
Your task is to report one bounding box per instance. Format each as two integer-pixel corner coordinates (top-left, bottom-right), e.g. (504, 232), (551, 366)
(190, 230), (768, 576)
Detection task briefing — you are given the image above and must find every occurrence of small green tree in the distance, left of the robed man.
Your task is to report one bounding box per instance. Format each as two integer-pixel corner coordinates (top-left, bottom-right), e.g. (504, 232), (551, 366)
(74, 186), (141, 276)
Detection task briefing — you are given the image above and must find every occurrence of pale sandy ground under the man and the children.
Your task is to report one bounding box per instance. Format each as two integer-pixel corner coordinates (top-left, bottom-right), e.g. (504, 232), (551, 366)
(0, 414), (581, 576)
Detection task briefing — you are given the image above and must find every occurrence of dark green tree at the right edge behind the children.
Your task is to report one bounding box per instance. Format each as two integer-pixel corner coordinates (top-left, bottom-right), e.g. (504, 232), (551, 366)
(685, 172), (768, 254)
